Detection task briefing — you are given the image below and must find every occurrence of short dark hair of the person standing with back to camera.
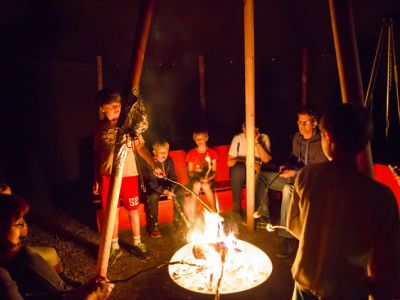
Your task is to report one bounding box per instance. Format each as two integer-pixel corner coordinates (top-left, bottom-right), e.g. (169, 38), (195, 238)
(320, 103), (372, 154)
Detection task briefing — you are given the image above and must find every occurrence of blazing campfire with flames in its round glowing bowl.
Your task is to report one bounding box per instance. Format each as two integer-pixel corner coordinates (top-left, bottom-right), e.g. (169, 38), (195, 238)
(169, 212), (272, 295)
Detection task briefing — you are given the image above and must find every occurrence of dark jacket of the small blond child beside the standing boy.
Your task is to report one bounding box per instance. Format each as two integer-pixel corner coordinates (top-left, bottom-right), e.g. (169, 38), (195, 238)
(144, 157), (177, 194)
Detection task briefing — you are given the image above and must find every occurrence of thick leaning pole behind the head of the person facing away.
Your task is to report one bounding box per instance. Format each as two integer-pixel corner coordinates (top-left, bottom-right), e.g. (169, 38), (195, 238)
(329, 0), (373, 177)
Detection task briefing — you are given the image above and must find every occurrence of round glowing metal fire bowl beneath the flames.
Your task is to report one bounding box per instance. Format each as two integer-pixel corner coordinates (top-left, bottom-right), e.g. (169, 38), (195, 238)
(168, 240), (272, 294)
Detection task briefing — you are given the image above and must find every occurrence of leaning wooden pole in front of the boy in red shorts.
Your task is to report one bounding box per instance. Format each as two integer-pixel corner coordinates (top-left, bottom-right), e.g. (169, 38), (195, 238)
(97, 0), (155, 277)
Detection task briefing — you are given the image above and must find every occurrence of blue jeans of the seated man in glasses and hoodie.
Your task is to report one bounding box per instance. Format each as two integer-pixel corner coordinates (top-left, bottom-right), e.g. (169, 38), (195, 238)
(256, 172), (294, 217)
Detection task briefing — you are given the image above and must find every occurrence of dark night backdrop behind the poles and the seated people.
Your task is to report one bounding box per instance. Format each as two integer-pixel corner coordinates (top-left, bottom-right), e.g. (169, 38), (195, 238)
(0, 0), (400, 223)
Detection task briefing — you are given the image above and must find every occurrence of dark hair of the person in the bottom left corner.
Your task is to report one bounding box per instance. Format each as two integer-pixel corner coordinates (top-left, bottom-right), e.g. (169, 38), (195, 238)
(0, 194), (29, 242)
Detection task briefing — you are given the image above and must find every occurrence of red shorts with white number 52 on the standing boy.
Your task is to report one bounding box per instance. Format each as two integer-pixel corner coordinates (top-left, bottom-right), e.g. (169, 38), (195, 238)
(100, 176), (140, 210)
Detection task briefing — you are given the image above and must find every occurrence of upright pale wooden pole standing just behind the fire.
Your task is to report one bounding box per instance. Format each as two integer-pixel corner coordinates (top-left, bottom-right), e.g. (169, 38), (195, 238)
(243, 0), (255, 231)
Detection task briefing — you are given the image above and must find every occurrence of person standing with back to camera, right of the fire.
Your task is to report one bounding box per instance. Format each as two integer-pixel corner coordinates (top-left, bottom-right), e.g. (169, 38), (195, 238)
(288, 104), (400, 300)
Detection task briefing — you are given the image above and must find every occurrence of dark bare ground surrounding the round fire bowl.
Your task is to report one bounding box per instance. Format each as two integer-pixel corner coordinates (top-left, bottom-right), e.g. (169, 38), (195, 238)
(25, 209), (293, 300)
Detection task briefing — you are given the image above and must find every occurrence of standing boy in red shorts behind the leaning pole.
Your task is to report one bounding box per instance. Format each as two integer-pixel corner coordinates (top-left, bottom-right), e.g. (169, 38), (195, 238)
(93, 90), (158, 265)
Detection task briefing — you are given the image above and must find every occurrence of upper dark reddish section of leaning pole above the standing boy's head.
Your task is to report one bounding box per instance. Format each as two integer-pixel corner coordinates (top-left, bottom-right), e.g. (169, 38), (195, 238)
(129, 0), (156, 92)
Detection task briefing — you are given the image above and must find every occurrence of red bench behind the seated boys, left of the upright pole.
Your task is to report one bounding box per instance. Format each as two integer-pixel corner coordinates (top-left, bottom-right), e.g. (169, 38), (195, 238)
(96, 145), (246, 231)
